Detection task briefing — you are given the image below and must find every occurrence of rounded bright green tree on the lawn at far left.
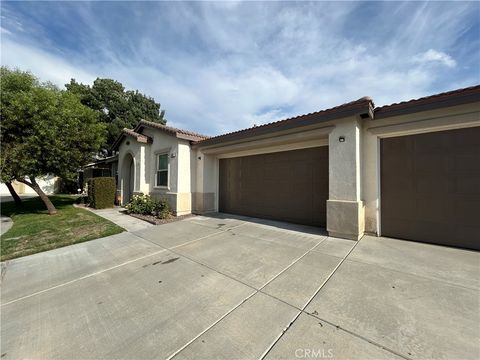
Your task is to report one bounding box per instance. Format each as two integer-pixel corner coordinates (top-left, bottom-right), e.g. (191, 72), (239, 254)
(0, 67), (106, 214)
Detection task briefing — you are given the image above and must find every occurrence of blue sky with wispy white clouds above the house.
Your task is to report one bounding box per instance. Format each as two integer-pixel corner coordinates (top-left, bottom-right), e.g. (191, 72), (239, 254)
(0, 1), (480, 135)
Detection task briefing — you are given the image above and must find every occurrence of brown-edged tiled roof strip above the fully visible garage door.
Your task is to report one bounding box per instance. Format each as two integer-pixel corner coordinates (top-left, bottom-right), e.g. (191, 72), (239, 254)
(195, 96), (374, 146)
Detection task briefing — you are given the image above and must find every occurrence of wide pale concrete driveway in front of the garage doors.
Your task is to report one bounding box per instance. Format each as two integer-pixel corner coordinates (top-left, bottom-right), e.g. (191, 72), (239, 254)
(1, 215), (480, 360)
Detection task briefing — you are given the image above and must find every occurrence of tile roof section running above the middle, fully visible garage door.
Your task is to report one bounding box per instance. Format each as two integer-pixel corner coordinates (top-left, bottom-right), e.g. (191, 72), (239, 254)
(195, 96), (374, 146)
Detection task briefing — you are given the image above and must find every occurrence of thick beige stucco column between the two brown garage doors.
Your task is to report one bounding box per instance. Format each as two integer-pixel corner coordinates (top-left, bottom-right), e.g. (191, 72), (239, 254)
(327, 117), (364, 240)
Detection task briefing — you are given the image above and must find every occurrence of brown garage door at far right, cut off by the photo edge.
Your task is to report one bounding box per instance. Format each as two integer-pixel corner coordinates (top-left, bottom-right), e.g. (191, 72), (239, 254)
(381, 127), (480, 250)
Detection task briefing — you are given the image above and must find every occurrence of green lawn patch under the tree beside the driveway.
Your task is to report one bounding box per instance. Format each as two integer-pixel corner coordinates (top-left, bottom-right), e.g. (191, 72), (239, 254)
(0, 195), (124, 261)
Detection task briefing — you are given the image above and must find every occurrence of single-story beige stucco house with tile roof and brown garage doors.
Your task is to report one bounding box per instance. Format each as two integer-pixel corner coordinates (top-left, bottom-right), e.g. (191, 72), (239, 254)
(114, 86), (480, 249)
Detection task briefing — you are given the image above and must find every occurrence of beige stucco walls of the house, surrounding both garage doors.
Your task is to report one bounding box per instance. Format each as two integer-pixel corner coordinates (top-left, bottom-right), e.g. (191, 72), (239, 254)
(119, 100), (480, 233)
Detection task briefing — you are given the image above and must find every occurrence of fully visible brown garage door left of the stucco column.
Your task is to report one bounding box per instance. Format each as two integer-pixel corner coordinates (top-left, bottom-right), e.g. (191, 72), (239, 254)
(219, 146), (328, 226)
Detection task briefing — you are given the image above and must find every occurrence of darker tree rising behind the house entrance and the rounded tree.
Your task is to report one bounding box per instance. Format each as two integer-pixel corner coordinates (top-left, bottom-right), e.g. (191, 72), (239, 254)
(65, 78), (166, 149)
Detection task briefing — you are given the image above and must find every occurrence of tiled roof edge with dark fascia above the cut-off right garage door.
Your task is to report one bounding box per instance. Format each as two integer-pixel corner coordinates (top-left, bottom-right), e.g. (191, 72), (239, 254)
(375, 85), (480, 119)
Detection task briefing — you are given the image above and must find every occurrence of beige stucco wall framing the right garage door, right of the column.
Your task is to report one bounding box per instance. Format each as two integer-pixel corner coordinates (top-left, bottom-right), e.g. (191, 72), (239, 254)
(361, 103), (480, 235)
